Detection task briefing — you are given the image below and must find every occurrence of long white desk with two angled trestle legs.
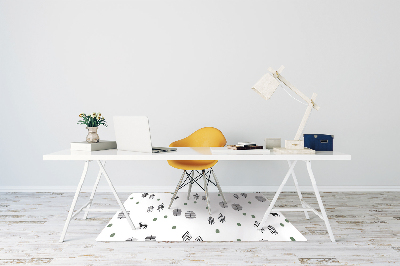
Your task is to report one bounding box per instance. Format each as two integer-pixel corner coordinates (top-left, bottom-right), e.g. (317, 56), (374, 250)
(43, 147), (351, 242)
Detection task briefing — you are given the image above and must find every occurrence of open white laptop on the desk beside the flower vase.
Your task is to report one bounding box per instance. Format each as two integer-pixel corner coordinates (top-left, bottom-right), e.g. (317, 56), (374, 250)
(113, 116), (176, 153)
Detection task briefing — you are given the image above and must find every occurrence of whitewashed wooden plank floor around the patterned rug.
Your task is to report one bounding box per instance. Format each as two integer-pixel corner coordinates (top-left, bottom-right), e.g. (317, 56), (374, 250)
(0, 192), (400, 265)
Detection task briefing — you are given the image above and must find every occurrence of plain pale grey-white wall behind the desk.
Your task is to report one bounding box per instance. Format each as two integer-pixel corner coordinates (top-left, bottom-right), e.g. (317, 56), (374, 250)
(0, 0), (400, 190)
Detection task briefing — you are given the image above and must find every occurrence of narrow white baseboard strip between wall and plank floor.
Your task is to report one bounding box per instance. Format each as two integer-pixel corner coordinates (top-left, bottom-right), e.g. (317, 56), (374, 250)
(0, 186), (400, 192)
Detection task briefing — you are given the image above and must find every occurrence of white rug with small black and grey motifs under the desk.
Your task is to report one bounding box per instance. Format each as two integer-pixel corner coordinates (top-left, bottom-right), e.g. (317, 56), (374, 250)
(96, 192), (307, 241)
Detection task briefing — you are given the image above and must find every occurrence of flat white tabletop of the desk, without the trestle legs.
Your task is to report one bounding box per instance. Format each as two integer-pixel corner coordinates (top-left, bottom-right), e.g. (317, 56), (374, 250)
(43, 147), (351, 161)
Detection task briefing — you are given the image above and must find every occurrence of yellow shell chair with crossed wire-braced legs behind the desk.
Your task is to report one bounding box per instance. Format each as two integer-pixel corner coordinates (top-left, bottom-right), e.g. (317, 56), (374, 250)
(168, 127), (226, 214)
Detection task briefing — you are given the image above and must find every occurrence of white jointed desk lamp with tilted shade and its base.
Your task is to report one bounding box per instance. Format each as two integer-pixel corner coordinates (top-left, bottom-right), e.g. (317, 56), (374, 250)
(252, 66), (319, 154)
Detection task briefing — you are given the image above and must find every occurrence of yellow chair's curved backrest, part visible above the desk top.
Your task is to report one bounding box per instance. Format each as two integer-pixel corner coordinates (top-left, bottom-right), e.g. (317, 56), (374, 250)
(169, 127), (226, 147)
